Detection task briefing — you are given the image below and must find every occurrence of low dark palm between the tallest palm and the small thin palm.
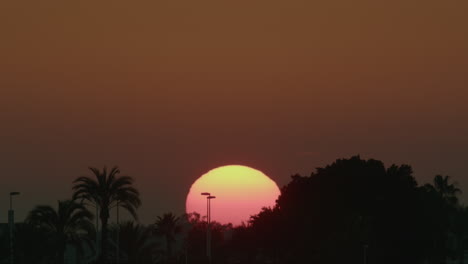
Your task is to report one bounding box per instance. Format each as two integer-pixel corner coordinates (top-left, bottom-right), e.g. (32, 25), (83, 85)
(111, 221), (158, 264)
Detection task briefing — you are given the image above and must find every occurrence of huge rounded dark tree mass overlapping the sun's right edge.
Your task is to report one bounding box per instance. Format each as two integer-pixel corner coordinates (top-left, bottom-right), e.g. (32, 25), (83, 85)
(252, 156), (436, 263)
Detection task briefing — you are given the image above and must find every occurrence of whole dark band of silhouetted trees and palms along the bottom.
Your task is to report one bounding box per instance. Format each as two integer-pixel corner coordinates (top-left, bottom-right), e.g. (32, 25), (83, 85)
(0, 156), (468, 264)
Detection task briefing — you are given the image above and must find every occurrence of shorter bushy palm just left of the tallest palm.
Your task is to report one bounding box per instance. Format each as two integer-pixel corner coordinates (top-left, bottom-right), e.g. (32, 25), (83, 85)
(26, 200), (95, 263)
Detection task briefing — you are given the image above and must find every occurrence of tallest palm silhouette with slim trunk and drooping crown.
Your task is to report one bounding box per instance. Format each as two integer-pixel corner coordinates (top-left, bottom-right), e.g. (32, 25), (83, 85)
(73, 167), (141, 263)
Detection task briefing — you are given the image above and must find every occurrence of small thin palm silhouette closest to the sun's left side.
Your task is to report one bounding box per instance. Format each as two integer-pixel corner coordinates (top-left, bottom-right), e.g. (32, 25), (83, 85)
(154, 213), (181, 259)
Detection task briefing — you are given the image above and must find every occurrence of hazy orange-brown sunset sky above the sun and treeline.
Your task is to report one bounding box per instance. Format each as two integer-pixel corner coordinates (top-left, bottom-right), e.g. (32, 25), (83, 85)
(0, 0), (468, 223)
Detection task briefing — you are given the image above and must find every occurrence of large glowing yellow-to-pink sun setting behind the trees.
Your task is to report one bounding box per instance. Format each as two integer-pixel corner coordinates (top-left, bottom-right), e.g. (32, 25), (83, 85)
(186, 165), (280, 226)
